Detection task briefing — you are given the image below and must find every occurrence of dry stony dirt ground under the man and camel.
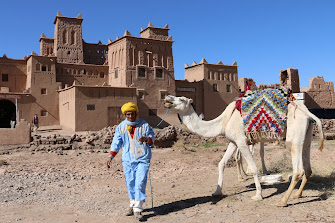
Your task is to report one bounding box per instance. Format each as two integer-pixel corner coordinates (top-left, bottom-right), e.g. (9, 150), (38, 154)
(0, 132), (335, 223)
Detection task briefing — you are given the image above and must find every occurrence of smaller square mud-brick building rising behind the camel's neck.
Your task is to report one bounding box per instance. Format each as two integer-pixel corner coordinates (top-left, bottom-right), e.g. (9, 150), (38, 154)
(176, 59), (239, 120)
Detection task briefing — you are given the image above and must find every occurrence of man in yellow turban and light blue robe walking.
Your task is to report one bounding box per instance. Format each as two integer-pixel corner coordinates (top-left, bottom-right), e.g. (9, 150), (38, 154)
(107, 102), (155, 220)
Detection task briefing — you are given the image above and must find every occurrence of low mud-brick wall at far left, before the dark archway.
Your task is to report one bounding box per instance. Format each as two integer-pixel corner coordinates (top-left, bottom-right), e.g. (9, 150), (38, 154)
(0, 119), (31, 145)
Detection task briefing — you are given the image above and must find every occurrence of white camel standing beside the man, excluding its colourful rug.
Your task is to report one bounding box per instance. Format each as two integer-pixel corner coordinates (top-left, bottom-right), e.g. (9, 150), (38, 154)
(165, 95), (323, 206)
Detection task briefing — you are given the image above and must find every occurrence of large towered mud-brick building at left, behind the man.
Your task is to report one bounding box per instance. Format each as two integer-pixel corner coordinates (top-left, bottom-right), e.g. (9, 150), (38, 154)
(0, 12), (175, 131)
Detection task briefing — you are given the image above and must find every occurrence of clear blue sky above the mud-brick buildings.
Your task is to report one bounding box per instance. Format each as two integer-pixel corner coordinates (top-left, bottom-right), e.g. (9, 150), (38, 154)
(0, 0), (335, 87)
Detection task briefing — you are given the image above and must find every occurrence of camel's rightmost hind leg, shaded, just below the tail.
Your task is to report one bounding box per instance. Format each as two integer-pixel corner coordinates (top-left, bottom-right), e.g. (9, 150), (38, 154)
(293, 123), (313, 198)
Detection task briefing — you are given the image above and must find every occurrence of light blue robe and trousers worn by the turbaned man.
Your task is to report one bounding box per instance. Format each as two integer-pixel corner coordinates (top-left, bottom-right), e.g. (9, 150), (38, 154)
(111, 119), (155, 201)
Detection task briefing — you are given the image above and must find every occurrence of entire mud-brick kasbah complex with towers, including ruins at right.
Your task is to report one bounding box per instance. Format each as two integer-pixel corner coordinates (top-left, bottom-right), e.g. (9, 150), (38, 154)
(0, 12), (335, 131)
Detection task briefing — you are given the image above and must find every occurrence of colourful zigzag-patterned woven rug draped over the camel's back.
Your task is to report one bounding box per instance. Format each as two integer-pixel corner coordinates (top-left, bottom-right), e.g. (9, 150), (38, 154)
(241, 87), (290, 143)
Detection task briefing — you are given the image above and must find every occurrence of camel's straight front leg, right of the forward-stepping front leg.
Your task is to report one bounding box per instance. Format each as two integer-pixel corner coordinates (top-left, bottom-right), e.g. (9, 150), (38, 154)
(238, 144), (263, 200)
